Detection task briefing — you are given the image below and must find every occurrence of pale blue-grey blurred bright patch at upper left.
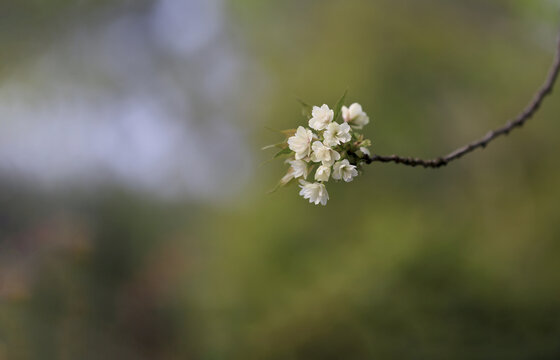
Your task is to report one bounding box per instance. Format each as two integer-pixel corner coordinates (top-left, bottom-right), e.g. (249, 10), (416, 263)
(0, 0), (264, 200)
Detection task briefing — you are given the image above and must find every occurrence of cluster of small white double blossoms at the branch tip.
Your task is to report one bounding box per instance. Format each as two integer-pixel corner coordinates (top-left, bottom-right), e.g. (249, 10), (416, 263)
(266, 101), (371, 205)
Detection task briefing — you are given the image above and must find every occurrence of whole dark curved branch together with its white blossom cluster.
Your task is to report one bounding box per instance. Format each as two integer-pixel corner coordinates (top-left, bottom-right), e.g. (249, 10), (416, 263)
(263, 31), (560, 197)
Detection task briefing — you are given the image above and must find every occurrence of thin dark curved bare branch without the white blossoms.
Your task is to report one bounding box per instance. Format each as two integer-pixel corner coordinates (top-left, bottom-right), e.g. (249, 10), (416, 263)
(364, 30), (560, 168)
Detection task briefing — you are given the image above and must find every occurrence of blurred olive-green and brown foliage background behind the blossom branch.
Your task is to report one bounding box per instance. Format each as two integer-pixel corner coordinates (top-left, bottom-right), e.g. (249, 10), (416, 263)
(0, 0), (560, 359)
